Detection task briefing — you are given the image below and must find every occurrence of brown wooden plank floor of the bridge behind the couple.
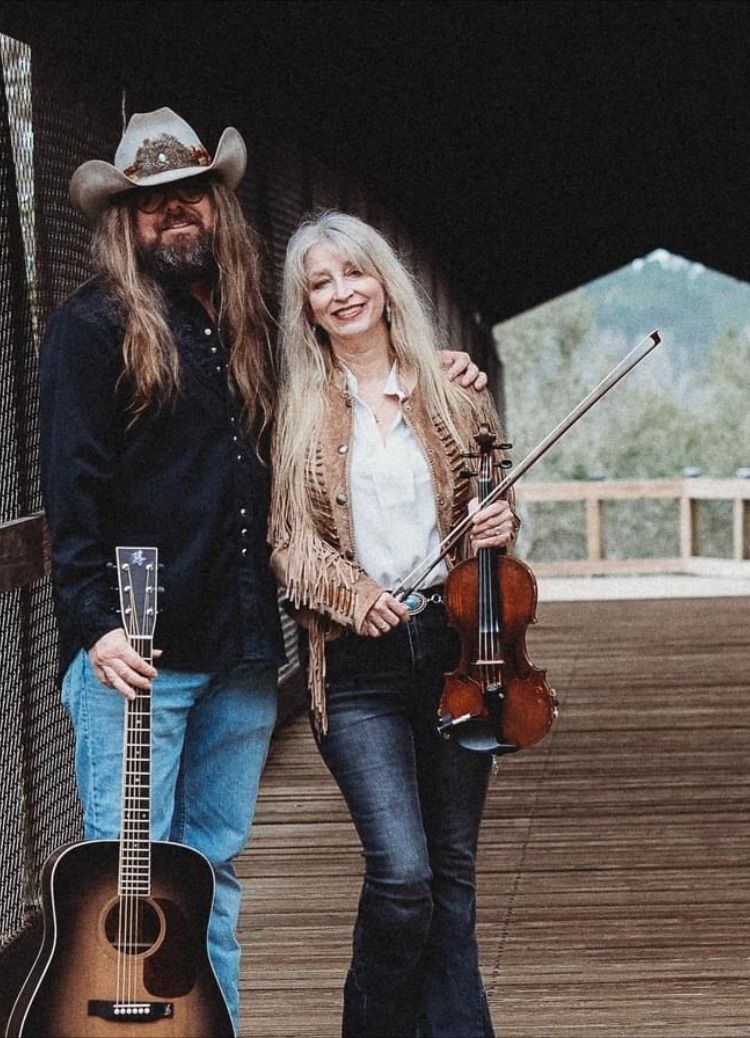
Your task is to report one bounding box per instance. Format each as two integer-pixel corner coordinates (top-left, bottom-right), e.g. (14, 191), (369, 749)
(241, 598), (750, 1038)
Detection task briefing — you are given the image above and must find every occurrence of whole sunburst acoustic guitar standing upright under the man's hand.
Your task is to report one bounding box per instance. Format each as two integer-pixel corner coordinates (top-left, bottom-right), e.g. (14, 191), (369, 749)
(5, 548), (234, 1038)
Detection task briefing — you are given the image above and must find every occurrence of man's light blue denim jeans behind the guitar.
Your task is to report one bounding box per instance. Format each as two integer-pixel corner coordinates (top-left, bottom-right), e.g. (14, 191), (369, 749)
(62, 652), (277, 1029)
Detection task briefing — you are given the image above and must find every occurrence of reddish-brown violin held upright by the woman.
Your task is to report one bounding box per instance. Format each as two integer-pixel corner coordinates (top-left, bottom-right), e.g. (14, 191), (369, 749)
(438, 425), (557, 754)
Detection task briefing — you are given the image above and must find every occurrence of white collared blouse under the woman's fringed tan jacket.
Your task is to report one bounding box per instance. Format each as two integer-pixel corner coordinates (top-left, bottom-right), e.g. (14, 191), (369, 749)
(346, 363), (448, 588)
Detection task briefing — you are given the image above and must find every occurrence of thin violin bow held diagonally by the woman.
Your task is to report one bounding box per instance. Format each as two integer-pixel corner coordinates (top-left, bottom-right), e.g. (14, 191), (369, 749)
(391, 330), (662, 601)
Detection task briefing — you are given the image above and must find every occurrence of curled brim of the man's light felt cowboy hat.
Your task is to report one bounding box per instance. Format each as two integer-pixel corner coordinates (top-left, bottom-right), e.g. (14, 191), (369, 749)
(71, 127), (247, 220)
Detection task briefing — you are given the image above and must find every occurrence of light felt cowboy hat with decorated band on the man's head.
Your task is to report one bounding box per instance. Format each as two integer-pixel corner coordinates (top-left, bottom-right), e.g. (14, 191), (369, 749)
(71, 108), (247, 219)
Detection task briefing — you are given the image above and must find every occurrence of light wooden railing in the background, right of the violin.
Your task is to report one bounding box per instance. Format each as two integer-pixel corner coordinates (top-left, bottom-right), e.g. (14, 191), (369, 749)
(516, 479), (750, 576)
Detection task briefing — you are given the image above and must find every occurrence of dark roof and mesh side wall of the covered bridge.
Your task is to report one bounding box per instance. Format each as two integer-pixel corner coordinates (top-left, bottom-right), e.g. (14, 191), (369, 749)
(0, 0), (750, 1020)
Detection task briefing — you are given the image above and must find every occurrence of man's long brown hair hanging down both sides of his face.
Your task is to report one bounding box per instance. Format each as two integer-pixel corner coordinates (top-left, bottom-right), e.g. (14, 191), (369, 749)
(92, 182), (273, 434)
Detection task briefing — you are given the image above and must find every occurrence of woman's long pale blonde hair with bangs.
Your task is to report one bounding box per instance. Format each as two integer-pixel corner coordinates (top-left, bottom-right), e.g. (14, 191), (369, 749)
(274, 211), (480, 515)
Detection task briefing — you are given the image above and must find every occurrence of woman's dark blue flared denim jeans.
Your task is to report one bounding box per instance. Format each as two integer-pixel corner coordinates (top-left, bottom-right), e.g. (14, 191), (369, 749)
(316, 605), (493, 1038)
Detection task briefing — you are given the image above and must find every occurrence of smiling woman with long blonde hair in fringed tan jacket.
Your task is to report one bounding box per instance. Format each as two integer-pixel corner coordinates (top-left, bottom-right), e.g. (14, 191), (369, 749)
(271, 213), (517, 1038)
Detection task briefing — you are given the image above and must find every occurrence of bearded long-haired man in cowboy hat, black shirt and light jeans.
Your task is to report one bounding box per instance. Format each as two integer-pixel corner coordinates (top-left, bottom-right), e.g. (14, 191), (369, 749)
(40, 108), (483, 1027)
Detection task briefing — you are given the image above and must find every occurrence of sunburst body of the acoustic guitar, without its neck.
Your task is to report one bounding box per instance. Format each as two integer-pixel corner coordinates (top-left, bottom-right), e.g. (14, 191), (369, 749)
(6, 840), (234, 1038)
